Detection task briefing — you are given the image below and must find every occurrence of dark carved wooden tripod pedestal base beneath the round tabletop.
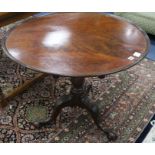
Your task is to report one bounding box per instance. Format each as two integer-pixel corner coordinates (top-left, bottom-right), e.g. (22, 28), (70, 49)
(36, 78), (117, 141)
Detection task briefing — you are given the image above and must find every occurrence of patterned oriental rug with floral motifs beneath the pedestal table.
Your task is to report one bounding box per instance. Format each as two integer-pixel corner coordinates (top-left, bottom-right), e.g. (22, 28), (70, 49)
(0, 18), (155, 143)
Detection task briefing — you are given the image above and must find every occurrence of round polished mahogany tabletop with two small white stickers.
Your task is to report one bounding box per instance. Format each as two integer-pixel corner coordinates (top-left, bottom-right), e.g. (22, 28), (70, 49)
(3, 13), (149, 77)
